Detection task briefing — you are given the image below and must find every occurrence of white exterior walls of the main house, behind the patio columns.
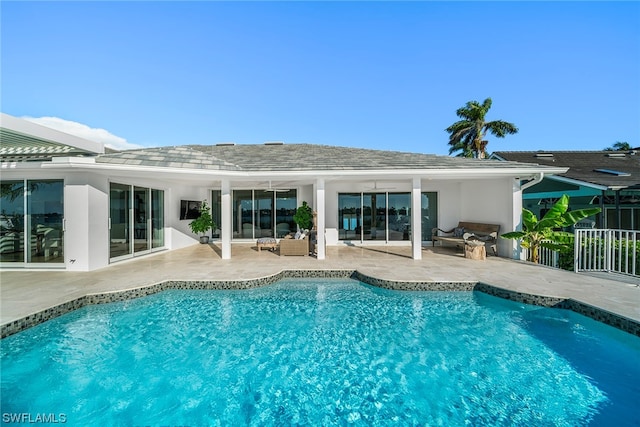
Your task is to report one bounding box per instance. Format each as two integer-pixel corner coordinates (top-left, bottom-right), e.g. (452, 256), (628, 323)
(2, 167), (522, 271)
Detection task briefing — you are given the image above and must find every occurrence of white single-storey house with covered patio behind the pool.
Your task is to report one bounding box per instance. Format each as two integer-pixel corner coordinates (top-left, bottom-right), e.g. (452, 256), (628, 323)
(0, 114), (566, 271)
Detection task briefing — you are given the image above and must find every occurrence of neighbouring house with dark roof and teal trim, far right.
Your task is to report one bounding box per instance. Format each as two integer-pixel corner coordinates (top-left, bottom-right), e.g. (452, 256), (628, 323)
(491, 150), (640, 230)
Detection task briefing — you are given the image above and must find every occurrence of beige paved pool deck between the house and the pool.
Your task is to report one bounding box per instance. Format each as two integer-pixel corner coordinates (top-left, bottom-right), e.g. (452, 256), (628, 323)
(0, 244), (640, 338)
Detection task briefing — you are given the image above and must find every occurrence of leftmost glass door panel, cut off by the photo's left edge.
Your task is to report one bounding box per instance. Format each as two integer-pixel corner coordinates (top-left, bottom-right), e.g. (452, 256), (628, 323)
(0, 181), (24, 262)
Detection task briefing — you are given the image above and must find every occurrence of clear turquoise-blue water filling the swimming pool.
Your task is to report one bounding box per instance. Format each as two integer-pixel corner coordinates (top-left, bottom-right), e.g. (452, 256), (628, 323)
(1, 279), (640, 426)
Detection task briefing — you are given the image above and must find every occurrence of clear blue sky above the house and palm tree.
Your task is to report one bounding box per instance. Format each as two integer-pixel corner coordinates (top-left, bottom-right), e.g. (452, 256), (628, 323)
(0, 1), (640, 154)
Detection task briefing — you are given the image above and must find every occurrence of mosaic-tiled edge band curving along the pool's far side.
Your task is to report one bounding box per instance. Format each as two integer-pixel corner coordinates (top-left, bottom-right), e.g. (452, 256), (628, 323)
(0, 269), (640, 338)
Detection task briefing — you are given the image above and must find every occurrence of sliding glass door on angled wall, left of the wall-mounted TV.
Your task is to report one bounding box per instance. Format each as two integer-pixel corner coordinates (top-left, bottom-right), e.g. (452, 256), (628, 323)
(109, 183), (164, 260)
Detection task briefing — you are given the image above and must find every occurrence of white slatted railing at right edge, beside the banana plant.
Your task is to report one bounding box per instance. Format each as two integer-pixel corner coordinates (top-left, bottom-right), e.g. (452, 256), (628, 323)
(574, 229), (640, 276)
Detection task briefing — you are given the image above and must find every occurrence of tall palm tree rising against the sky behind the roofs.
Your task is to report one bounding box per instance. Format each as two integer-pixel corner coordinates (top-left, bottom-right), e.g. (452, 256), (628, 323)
(446, 98), (518, 159)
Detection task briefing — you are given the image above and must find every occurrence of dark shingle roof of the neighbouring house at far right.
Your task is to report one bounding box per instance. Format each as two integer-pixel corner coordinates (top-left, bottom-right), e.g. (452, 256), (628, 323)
(492, 150), (640, 189)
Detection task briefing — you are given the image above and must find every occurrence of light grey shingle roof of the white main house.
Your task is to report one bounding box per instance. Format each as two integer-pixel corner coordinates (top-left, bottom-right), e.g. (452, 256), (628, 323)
(96, 144), (556, 171)
